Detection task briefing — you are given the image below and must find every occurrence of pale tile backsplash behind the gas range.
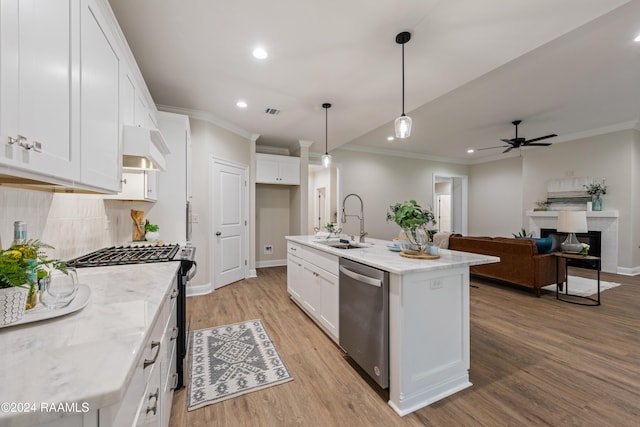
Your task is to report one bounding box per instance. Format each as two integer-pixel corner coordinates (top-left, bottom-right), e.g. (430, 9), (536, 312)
(0, 186), (152, 260)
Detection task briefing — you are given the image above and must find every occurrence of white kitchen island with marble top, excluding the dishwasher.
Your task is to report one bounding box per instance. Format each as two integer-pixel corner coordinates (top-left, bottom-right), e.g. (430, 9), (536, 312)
(286, 236), (500, 415)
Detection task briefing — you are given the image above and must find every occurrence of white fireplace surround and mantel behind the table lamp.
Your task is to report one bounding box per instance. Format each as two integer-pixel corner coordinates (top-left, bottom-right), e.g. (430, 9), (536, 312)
(526, 211), (620, 273)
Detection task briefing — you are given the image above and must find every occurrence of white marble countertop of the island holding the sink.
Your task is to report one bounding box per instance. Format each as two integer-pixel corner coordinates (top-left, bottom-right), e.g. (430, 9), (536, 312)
(286, 236), (500, 274)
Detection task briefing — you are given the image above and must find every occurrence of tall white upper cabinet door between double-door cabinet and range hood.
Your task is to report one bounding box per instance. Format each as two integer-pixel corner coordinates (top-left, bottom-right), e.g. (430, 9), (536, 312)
(80, 0), (121, 191)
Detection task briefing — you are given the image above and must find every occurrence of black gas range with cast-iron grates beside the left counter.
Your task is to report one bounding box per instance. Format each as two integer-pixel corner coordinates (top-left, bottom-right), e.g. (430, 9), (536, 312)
(67, 245), (198, 389)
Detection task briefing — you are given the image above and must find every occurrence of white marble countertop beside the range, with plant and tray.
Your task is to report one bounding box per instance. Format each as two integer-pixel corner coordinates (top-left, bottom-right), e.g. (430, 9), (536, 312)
(0, 261), (180, 427)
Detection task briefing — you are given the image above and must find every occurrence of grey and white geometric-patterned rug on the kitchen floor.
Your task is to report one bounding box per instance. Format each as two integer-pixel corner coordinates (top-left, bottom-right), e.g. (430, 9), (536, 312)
(187, 319), (293, 411)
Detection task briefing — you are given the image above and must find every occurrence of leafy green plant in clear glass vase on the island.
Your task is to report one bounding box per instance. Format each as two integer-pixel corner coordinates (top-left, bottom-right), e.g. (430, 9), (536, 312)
(387, 200), (436, 253)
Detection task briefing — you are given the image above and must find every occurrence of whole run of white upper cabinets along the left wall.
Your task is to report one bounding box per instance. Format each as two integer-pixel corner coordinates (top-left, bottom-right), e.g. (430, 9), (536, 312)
(0, 0), (157, 193)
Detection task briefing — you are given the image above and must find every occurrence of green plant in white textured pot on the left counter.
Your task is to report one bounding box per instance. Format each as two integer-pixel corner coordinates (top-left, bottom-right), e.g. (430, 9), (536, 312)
(0, 240), (67, 324)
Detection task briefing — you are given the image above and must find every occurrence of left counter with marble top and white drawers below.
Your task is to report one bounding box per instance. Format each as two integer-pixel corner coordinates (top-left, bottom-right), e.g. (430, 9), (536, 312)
(0, 261), (180, 427)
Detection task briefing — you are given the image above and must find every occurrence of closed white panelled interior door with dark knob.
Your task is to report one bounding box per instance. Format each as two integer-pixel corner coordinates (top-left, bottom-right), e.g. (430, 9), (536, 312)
(211, 160), (247, 289)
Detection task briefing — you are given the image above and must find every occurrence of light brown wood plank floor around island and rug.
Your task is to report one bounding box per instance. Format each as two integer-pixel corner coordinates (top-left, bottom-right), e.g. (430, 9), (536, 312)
(170, 267), (640, 427)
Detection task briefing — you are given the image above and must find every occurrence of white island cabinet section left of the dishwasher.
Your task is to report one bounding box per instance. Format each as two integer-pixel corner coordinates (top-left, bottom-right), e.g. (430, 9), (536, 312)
(287, 242), (339, 343)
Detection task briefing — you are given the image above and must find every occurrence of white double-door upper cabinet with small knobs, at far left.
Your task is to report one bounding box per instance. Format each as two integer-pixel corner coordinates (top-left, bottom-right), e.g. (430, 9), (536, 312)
(0, 0), (80, 180)
